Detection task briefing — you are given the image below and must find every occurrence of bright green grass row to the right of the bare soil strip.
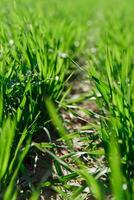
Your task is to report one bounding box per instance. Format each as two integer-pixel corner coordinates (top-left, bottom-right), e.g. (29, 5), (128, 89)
(90, 3), (134, 199)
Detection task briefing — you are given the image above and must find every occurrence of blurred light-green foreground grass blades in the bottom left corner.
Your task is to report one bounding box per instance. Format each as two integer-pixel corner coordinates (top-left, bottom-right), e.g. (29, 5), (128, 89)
(0, 94), (31, 199)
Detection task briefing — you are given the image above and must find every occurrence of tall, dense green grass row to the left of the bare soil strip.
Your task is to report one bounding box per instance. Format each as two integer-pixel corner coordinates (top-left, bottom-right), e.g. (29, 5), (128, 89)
(0, 0), (94, 199)
